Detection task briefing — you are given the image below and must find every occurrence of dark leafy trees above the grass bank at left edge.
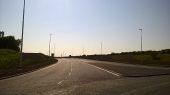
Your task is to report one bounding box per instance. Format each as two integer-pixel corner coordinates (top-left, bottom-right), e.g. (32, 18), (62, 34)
(0, 36), (21, 51)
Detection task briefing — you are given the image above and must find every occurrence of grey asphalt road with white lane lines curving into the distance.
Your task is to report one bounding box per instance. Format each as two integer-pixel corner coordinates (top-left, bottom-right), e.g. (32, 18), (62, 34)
(0, 58), (170, 95)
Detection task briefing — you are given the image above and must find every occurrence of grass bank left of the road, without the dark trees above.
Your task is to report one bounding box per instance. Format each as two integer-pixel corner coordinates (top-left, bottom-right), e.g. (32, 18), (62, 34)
(0, 49), (57, 78)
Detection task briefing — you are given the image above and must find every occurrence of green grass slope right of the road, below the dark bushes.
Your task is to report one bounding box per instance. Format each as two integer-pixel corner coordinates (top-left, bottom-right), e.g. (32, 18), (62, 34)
(80, 54), (170, 67)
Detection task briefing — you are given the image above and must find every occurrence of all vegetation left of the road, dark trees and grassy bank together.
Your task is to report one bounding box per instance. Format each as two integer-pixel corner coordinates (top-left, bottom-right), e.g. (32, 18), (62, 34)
(0, 36), (57, 79)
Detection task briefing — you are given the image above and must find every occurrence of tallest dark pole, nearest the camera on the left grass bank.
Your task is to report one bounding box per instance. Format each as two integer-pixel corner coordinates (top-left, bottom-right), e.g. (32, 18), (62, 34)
(19, 0), (25, 66)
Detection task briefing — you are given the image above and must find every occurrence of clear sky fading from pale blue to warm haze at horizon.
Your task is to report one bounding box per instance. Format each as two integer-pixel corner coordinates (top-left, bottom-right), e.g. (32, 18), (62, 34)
(0, 0), (170, 56)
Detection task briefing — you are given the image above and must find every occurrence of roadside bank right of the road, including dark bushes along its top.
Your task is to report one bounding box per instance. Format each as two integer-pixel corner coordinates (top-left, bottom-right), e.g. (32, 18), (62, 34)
(76, 49), (170, 67)
